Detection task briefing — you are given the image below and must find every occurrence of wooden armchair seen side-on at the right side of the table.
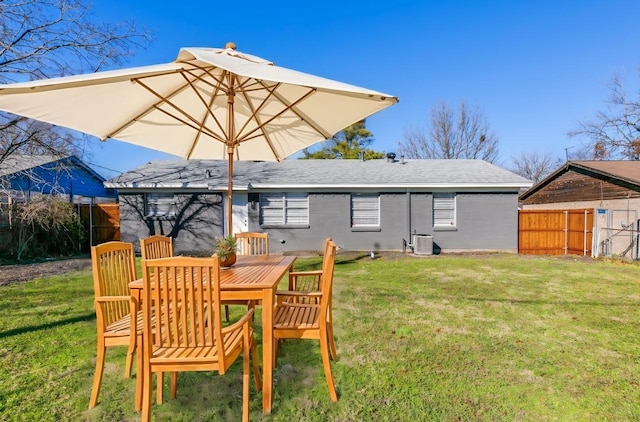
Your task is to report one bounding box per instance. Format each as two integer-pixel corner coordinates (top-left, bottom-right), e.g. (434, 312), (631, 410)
(273, 241), (338, 401)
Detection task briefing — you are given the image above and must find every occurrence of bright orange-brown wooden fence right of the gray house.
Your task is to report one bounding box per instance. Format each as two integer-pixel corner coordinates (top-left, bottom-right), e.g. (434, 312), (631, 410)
(518, 209), (593, 256)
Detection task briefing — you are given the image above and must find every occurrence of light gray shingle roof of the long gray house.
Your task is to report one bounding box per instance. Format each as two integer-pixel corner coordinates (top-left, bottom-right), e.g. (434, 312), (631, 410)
(105, 159), (531, 190)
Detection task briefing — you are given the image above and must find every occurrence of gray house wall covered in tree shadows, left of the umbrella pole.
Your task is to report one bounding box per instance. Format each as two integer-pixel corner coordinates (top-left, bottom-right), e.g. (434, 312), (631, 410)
(119, 193), (223, 255)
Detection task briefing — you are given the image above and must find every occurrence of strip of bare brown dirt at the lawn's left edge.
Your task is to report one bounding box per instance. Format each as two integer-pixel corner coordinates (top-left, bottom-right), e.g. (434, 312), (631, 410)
(0, 258), (91, 286)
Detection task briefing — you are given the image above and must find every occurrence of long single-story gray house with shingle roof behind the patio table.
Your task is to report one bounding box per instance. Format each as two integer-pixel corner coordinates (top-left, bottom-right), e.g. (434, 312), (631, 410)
(105, 159), (531, 253)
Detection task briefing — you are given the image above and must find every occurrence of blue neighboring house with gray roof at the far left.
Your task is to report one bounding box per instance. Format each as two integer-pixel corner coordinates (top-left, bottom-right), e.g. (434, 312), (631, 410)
(0, 154), (116, 203)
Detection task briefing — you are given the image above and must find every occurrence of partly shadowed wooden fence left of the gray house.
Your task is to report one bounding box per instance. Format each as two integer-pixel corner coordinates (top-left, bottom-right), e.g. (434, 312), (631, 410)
(77, 204), (120, 250)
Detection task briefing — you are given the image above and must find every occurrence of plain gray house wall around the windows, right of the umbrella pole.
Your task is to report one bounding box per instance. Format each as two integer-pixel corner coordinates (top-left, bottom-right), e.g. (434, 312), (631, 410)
(249, 192), (518, 253)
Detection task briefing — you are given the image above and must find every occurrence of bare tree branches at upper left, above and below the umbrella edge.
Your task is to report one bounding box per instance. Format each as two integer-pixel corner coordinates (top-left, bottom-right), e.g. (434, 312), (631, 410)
(0, 0), (150, 162)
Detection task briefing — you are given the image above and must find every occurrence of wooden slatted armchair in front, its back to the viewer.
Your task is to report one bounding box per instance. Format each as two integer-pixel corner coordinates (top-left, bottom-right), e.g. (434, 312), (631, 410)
(137, 256), (262, 422)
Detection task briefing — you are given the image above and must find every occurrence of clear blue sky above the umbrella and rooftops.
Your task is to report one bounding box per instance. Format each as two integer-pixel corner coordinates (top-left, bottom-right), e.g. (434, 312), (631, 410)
(90, 0), (640, 176)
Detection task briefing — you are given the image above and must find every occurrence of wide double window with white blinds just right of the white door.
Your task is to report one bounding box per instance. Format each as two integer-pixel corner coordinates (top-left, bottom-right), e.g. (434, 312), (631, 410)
(260, 193), (309, 226)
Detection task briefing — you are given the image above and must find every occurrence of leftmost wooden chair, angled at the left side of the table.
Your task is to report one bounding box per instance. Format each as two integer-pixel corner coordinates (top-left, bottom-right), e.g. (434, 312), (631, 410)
(89, 242), (143, 410)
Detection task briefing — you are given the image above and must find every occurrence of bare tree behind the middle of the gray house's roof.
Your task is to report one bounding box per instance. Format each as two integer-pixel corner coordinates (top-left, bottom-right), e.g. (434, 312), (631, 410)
(398, 101), (498, 163)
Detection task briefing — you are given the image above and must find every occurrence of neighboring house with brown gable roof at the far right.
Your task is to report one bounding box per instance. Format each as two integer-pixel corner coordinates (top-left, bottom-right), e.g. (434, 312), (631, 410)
(520, 161), (640, 259)
